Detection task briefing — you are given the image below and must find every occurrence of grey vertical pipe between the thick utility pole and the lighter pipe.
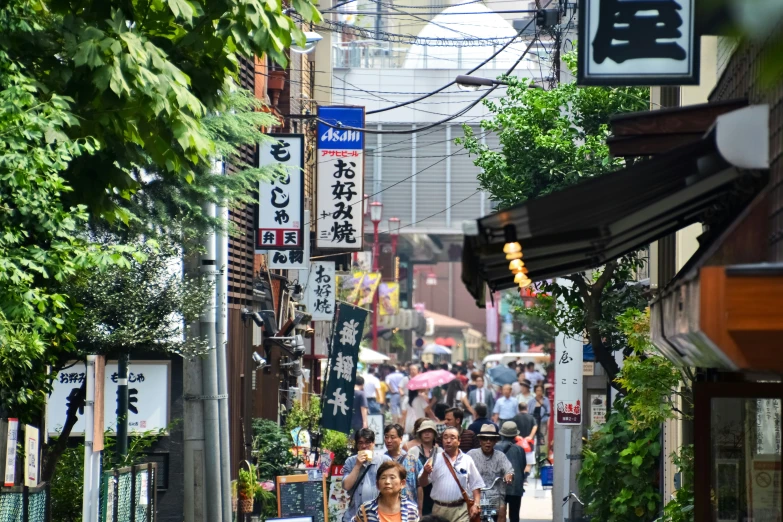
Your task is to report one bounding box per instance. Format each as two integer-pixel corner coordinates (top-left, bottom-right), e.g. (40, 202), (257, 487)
(199, 197), (223, 522)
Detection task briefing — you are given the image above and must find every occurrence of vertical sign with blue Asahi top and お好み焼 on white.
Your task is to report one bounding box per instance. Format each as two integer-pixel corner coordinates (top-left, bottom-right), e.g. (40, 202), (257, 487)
(315, 107), (364, 251)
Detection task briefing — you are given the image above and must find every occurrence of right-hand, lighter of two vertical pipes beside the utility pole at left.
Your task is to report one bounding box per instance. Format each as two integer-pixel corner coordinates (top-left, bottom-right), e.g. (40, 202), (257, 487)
(215, 165), (231, 522)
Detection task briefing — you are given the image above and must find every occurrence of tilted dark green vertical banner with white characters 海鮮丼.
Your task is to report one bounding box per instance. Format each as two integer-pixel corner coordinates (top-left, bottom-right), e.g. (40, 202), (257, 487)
(321, 304), (367, 433)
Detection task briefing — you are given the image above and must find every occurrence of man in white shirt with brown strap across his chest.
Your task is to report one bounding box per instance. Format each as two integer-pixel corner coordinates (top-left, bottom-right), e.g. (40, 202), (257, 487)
(419, 427), (484, 522)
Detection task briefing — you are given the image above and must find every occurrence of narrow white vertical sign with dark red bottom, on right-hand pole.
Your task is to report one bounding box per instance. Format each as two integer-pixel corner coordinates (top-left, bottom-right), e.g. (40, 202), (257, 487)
(554, 335), (583, 424)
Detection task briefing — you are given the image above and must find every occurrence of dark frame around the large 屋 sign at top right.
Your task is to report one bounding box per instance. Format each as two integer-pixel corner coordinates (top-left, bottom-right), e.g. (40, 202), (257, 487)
(576, 0), (701, 87)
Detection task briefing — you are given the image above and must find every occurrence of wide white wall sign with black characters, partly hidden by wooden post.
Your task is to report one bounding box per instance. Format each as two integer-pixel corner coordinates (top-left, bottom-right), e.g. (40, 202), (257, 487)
(46, 360), (171, 436)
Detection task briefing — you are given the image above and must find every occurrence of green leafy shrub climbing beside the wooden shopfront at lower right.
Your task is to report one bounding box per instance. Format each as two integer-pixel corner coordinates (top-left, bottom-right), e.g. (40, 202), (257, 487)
(578, 310), (693, 522)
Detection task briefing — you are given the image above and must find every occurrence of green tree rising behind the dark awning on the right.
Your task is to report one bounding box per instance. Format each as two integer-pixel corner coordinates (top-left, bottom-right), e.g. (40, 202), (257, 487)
(459, 55), (649, 382)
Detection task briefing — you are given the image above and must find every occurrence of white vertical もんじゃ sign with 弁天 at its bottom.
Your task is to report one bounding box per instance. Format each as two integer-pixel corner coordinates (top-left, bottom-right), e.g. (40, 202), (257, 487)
(256, 134), (304, 249)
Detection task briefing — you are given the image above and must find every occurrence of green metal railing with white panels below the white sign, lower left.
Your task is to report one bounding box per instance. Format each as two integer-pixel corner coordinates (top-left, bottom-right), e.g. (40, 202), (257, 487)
(99, 462), (158, 522)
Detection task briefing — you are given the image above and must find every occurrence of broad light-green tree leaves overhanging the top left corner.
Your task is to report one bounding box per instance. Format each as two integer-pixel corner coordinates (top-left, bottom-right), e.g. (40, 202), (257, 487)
(0, 0), (320, 222)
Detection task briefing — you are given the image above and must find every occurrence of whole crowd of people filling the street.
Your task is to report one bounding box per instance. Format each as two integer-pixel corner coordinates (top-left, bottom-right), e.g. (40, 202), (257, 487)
(343, 361), (551, 522)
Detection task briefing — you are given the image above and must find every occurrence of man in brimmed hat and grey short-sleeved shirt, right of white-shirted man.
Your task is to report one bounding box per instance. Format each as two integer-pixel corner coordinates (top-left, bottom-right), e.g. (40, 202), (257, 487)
(468, 424), (514, 522)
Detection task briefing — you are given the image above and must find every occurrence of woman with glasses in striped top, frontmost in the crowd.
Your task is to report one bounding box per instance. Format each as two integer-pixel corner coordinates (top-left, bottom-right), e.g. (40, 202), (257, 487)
(352, 460), (419, 522)
